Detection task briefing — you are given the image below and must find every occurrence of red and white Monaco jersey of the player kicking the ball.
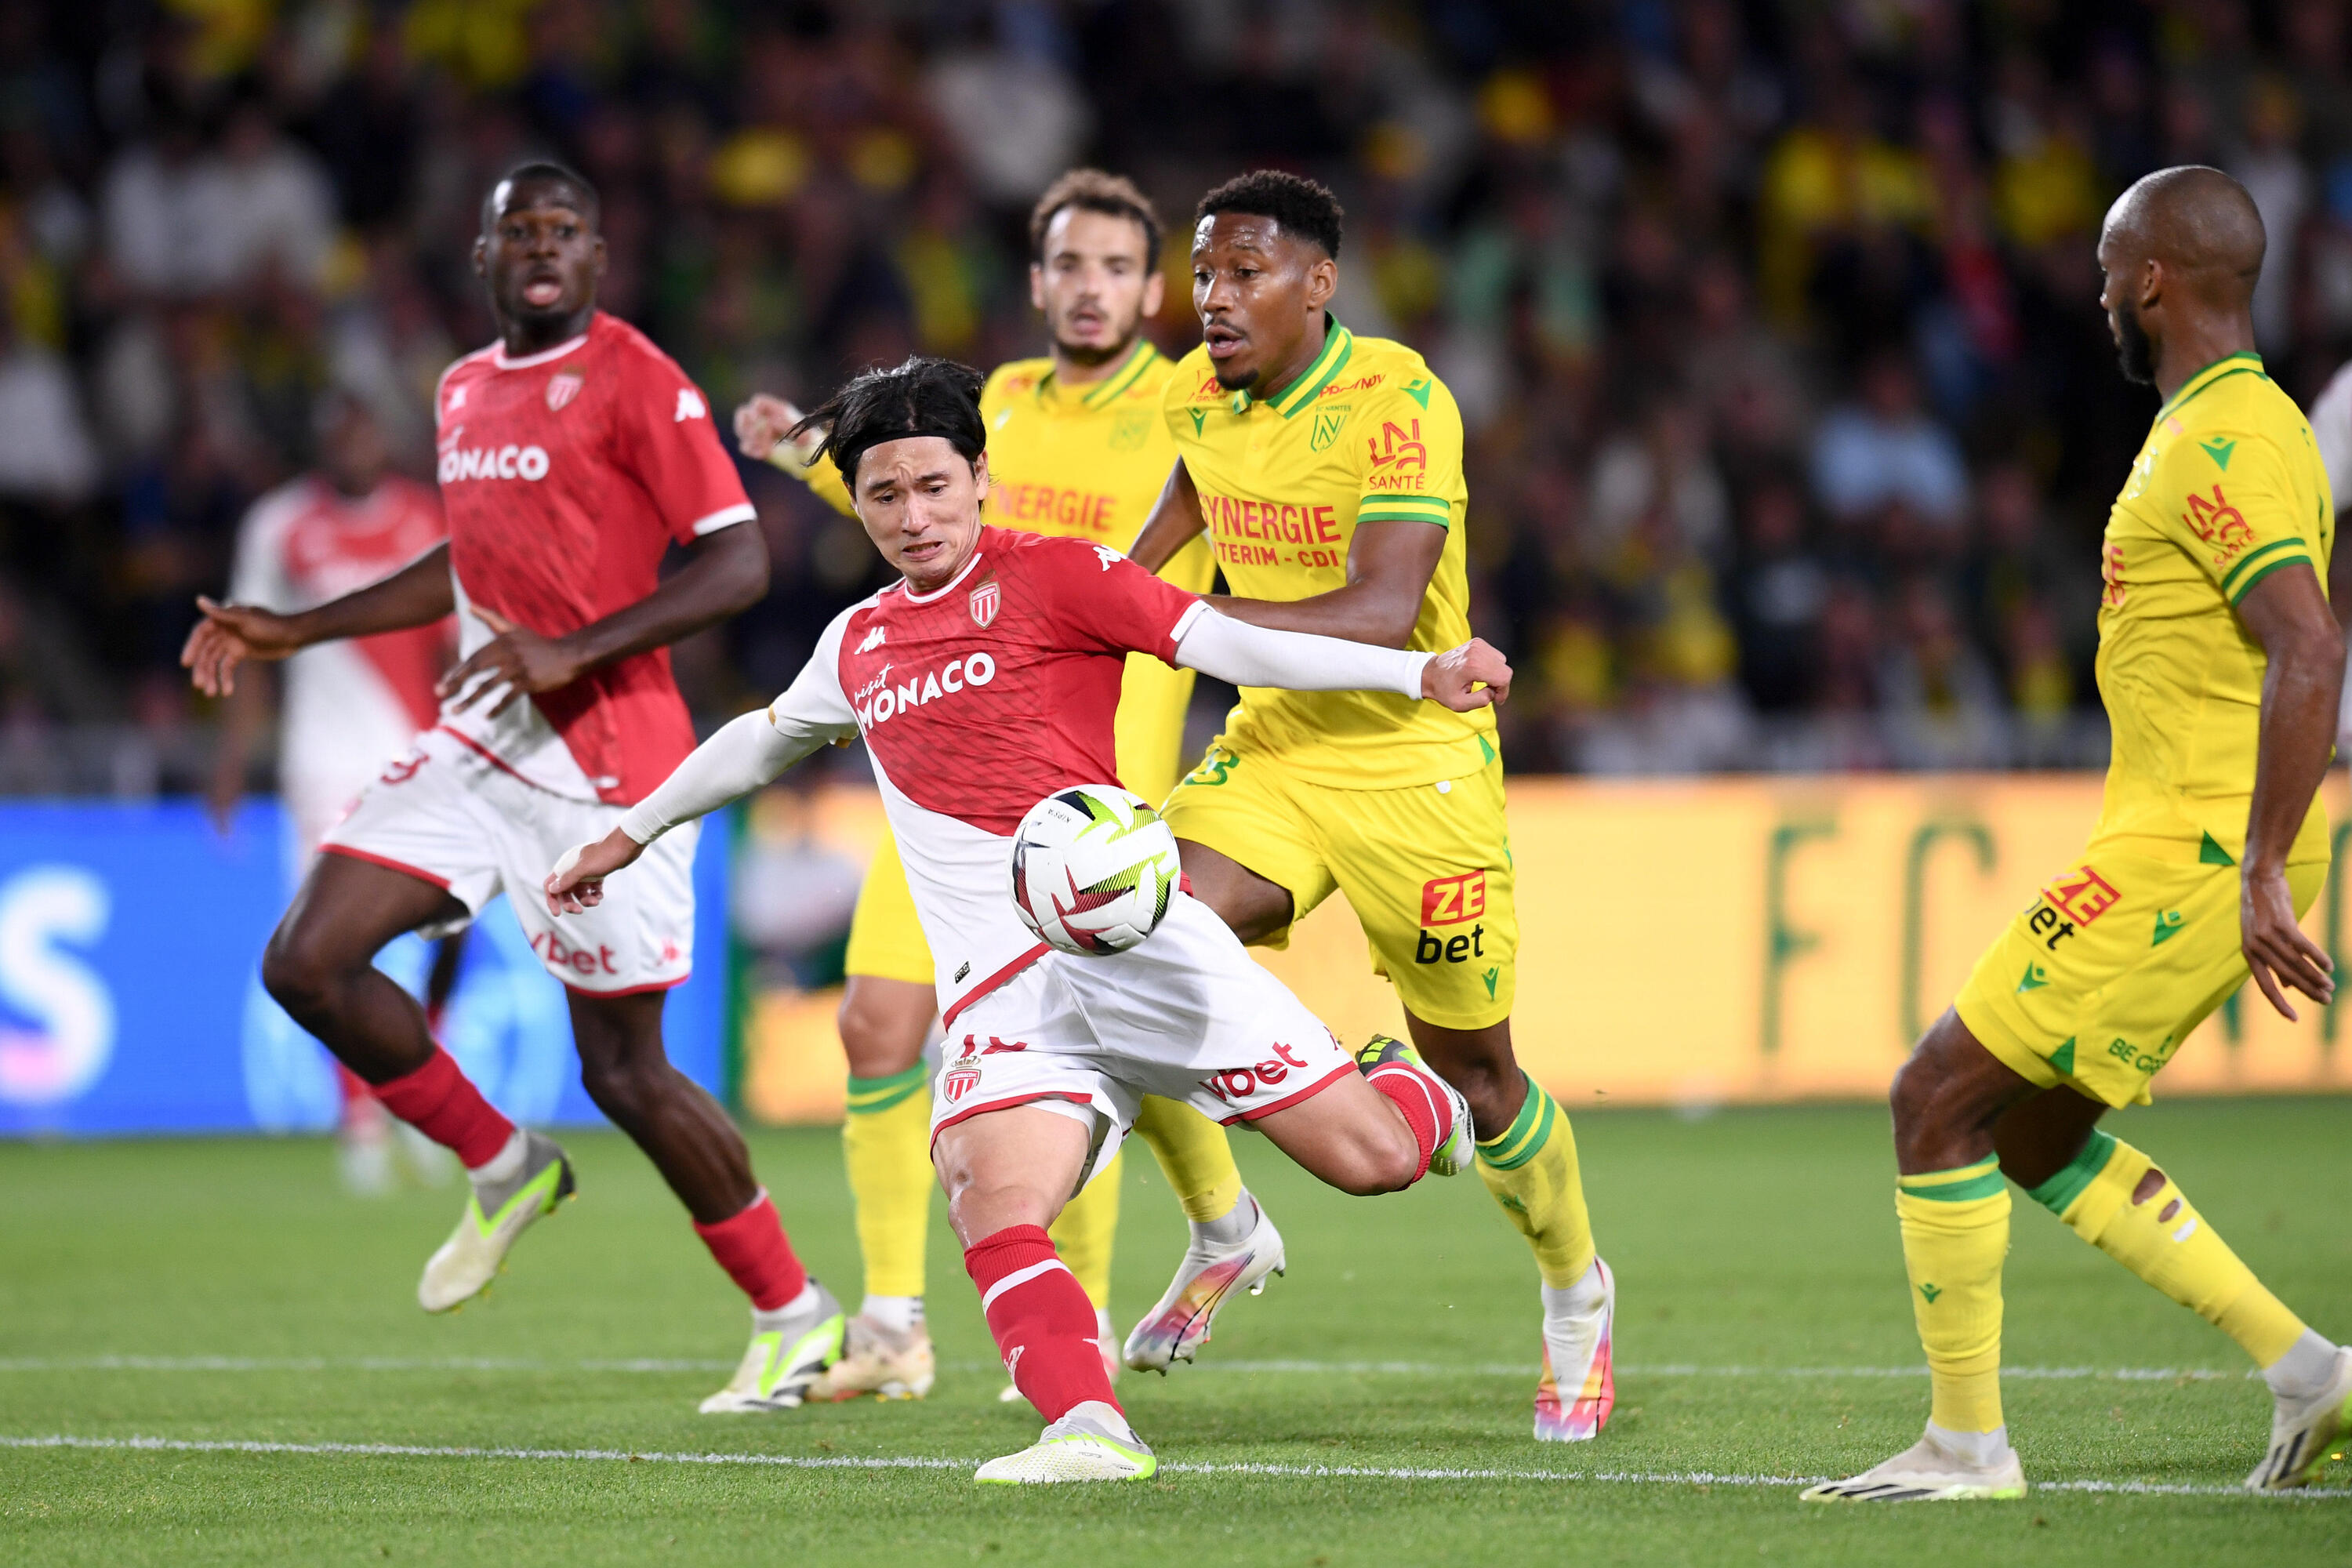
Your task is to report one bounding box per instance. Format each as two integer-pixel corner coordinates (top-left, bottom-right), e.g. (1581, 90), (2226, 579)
(769, 529), (1200, 1022)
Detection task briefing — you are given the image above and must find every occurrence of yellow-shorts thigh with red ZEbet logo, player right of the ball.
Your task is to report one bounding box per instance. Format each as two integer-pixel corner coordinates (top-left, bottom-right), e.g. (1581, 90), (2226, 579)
(1315, 762), (1519, 1032)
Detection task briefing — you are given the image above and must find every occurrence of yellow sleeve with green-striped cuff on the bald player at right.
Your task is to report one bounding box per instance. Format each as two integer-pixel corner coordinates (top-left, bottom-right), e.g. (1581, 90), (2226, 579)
(2157, 433), (2321, 604)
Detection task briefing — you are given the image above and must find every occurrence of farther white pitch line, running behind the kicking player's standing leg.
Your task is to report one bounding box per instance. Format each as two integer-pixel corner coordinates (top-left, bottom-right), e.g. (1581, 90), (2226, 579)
(0, 1356), (2260, 1382)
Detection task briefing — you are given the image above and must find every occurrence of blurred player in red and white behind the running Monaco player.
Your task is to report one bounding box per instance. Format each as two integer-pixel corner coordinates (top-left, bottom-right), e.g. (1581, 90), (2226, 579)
(209, 393), (466, 1194)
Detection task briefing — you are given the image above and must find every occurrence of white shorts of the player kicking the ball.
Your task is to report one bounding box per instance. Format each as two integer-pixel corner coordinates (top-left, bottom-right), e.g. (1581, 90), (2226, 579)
(931, 893), (1355, 1178)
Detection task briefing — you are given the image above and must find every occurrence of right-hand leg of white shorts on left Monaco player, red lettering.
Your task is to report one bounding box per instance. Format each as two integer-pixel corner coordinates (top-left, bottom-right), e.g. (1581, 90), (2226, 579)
(499, 799), (701, 996)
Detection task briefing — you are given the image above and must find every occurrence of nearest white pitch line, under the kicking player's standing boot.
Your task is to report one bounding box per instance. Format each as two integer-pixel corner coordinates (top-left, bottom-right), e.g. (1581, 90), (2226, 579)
(0, 1432), (2352, 1502)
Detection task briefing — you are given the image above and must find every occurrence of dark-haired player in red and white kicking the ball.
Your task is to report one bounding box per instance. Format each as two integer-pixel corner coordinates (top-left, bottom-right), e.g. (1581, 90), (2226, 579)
(546, 358), (1510, 1483)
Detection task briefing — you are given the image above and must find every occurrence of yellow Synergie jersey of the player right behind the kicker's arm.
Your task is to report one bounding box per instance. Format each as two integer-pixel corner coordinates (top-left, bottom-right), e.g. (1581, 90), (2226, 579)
(1167, 320), (1496, 789)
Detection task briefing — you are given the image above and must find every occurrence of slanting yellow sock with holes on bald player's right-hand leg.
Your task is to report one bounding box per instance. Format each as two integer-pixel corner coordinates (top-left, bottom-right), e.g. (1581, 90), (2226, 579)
(2030, 1128), (2303, 1366)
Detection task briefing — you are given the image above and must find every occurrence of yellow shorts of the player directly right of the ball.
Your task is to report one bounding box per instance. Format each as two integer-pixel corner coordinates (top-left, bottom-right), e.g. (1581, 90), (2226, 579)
(1162, 736), (1519, 1029)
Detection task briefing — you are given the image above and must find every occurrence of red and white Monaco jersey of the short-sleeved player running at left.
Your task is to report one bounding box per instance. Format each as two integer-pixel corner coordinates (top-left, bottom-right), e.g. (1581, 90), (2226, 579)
(433, 310), (753, 806)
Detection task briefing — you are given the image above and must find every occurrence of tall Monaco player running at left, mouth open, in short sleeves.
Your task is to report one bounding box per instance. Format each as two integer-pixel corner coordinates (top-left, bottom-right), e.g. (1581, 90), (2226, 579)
(183, 165), (842, 1410)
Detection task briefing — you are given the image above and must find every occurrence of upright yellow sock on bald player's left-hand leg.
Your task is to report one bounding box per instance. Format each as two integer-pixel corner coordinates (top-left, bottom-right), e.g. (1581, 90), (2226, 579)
(1896, 1154), (2009, 1432)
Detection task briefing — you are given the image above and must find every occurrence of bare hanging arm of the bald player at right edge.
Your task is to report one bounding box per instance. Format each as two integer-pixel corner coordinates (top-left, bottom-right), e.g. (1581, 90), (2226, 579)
(2237, 564), (2345, 1018)
